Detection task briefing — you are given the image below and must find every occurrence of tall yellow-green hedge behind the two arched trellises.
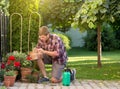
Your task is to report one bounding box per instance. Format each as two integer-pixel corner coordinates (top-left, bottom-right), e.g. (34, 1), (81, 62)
(8, 0), (40, 52)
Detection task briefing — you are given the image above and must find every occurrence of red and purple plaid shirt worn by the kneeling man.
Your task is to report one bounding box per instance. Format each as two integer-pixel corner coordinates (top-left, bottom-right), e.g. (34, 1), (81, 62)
(37, 34), (68, 64)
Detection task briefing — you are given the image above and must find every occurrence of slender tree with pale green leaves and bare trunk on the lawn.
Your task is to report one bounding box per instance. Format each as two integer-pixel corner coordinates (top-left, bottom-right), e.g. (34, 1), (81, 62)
(72, 0), (119, 67)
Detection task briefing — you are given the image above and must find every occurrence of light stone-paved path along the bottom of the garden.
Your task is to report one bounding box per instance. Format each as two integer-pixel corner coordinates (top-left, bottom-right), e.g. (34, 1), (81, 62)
(3, 80), (120, 89)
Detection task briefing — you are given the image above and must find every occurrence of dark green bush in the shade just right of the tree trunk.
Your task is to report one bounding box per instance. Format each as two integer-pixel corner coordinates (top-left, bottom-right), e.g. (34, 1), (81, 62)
(101, 23), (117, 51)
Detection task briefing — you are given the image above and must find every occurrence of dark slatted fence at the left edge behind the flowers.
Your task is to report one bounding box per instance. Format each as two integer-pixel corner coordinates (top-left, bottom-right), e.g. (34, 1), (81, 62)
(0, 10), (9, 61)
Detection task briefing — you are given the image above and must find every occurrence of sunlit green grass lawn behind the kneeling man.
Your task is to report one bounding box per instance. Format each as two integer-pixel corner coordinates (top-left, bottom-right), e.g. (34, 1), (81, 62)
(68, 48), (120, 80)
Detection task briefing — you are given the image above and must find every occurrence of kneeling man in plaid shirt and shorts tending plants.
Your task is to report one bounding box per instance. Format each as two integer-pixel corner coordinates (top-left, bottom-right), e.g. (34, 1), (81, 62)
(31, 26), (68, 83)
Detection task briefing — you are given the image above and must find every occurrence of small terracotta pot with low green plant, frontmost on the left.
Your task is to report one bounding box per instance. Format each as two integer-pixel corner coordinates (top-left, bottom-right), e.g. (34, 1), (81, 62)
(4, 70), (16, 86)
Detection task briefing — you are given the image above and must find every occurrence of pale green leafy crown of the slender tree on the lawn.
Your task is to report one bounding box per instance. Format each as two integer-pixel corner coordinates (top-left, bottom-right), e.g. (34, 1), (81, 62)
(72, 0), (120, 30)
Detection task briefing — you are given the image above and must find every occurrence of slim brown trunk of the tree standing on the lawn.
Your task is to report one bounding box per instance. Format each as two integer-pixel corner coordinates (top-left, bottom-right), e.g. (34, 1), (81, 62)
(97, 24), (102, 68)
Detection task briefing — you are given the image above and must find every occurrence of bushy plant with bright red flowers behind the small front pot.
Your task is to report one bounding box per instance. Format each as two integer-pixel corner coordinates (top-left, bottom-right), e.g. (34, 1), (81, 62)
(1, 51), (26, 80)
